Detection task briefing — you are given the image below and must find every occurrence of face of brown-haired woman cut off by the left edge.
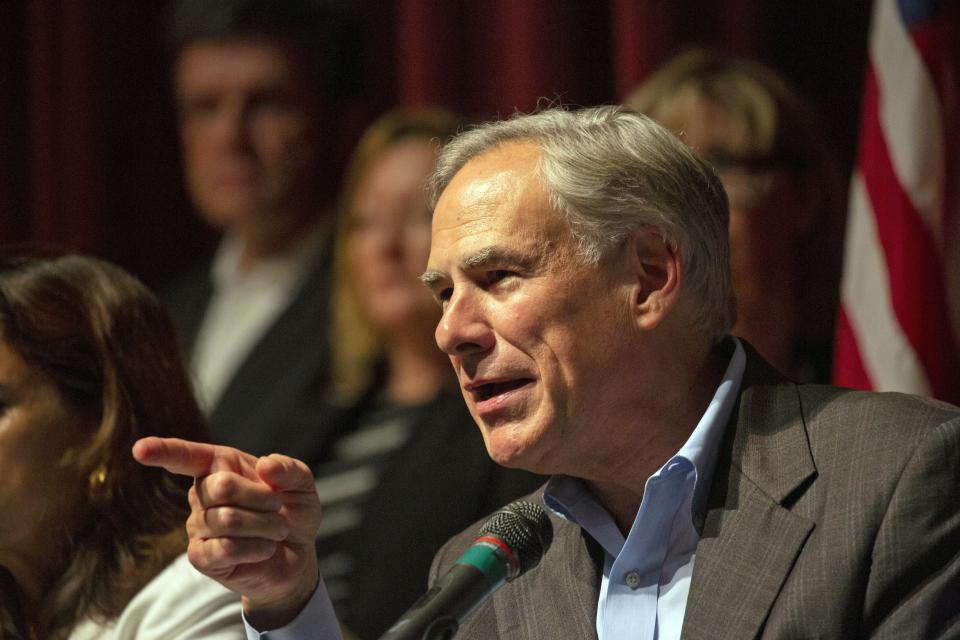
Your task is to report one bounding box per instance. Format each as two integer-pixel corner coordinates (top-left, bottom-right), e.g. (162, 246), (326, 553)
(0, 339), (84, 567)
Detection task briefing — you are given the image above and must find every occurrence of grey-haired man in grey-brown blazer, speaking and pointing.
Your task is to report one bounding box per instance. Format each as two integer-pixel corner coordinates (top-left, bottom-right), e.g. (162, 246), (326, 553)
(134, 107), (960, 639)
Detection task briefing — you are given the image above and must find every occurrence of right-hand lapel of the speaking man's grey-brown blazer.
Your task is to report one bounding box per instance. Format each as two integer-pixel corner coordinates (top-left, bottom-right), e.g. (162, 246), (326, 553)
(682, 344), (816, 640)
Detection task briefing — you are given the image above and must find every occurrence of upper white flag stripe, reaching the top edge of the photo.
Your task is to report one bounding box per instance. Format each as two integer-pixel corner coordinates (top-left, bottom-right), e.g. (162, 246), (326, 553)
(870, 0), (944, 239)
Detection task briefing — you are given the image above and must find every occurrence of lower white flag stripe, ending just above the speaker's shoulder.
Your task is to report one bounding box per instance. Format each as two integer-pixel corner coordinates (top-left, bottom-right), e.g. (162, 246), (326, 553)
(840, 170), (931, 396)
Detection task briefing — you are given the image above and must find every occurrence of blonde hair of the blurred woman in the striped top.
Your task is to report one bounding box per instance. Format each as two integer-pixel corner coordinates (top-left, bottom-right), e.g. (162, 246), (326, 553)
(332, 109), (461, 404)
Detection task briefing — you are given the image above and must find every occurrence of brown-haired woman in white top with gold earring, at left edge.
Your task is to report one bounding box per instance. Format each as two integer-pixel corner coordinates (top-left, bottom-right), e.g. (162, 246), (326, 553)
(0, 254), (245, 640)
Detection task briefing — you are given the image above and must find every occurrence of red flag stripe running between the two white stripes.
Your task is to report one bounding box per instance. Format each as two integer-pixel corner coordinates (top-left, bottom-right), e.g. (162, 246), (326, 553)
(859, 63), (960, 397)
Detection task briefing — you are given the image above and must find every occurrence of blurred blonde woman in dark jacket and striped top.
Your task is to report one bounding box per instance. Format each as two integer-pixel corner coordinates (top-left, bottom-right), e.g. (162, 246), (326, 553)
(314, 110), (540, 638)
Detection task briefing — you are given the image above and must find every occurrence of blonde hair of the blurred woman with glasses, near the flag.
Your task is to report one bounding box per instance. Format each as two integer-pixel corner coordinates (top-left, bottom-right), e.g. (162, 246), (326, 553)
(624, 49), (844, 364)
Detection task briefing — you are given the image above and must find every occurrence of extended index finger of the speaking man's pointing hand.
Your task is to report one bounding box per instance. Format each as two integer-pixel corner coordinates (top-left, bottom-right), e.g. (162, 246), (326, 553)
(133, 436), (257, 478)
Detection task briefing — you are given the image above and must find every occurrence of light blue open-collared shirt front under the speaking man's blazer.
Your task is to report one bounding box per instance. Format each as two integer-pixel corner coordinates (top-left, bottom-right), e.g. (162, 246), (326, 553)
(544, 338), (746, 640)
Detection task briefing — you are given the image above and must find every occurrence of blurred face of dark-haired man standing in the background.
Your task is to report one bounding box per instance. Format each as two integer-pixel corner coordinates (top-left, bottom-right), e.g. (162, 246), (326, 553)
(174, 39), (317, 228)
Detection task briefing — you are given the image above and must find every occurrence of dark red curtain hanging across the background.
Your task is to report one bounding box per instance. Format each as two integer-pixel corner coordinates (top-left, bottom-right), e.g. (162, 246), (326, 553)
(0, 0), (870, 285)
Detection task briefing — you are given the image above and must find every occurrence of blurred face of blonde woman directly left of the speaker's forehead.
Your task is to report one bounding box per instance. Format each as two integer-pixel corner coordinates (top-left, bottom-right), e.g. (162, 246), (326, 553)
(347, 138), (437, 335)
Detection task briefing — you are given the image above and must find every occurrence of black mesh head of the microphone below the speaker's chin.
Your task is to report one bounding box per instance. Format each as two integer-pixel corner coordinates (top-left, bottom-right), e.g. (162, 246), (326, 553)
(480, 500), (553, 580)
